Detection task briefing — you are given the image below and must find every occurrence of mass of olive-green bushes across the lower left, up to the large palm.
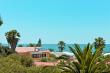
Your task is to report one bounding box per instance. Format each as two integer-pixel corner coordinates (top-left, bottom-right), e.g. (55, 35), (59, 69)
(0, 54), (61, 73)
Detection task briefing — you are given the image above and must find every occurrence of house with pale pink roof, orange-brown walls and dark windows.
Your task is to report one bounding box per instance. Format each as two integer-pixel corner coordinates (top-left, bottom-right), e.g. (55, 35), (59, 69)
(15, 47), (50, 60)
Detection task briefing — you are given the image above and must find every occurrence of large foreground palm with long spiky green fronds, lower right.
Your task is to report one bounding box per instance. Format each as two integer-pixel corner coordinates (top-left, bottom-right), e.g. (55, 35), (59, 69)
(61, 44), (106, 73)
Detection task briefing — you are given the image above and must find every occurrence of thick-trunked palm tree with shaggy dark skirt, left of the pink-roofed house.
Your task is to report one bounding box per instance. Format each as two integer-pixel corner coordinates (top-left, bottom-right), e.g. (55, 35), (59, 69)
(5, 30), (20, 52)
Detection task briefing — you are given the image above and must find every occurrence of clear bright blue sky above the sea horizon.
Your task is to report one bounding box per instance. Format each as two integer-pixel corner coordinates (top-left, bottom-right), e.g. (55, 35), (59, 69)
(0, 0), (110, 44)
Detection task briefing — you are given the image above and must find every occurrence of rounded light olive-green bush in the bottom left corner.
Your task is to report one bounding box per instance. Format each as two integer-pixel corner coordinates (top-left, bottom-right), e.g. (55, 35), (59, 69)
(0, 57), (26, 73)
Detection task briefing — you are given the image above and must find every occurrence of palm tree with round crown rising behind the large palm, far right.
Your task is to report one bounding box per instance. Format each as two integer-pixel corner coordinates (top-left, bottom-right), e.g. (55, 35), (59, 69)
(94, 37), (105, 53)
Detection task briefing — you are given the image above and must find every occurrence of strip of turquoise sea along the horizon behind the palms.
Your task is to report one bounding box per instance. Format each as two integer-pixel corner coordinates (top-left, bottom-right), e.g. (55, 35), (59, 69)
(41, 44), (110, 53)
